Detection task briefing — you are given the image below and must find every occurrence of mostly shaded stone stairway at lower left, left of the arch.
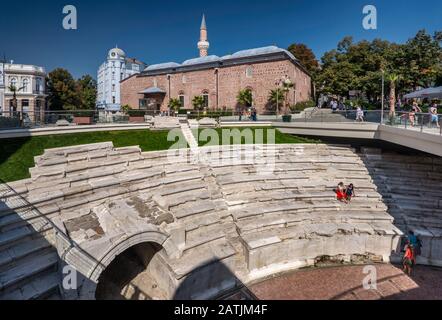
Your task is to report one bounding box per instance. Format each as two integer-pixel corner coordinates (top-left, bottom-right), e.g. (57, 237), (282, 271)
(0, 184), (61, 300)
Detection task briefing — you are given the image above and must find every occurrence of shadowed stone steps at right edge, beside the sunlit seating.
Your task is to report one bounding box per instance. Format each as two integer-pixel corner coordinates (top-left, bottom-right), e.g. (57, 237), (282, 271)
(363, 149), (442, 266)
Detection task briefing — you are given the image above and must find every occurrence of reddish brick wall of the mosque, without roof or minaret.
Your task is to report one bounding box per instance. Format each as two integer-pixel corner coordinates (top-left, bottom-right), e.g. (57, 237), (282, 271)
(121, 60), (311, 113)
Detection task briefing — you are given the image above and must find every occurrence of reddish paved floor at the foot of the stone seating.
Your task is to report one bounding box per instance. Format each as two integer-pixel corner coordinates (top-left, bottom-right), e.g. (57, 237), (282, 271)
(225, 264), (442, 300)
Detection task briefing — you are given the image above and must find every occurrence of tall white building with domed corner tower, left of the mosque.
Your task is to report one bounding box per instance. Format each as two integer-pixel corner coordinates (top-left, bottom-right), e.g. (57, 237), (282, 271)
(97, 48), (146, 111)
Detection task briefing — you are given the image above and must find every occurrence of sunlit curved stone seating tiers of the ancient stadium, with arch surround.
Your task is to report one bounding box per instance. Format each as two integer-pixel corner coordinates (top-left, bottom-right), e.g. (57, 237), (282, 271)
(0, 143), (408, 299)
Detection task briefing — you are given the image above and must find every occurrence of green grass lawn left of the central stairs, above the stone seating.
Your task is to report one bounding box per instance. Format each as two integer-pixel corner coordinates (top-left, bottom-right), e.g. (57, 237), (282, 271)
(0, 130), (182, 182)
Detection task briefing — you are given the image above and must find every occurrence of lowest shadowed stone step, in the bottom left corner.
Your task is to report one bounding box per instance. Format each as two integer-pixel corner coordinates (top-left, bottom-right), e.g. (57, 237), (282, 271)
(0, 272), (61, 300)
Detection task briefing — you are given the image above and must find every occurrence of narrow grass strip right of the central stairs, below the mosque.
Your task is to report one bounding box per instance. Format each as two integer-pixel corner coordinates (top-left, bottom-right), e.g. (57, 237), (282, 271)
(198, 127), (321, 147)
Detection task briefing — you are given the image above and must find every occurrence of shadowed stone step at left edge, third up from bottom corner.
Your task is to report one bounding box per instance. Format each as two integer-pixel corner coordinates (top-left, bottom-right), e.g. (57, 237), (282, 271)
(0, 238), (52, 272)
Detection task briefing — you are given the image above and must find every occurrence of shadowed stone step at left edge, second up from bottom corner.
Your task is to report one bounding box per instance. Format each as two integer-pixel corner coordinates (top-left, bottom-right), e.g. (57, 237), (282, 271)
(0, 252), (58, 292)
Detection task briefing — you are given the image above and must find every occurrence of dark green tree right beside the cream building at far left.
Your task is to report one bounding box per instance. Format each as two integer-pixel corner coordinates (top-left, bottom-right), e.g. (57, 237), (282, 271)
(47, 68), (81, 110)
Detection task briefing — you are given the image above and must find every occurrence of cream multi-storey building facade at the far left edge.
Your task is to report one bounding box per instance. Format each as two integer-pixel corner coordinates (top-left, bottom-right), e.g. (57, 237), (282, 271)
(0, 61), (47, 121)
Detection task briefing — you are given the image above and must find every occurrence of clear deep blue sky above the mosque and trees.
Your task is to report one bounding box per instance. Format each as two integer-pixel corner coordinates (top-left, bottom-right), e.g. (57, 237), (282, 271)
(0, 0), (442, 78)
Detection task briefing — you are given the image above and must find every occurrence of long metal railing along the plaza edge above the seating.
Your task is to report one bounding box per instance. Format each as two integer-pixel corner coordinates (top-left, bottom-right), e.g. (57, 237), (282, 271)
(0, 108), (442, 135)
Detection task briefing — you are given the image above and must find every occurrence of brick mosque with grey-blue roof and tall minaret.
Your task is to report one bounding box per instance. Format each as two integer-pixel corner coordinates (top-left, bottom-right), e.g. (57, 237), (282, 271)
(121, 17), (312, 114)
